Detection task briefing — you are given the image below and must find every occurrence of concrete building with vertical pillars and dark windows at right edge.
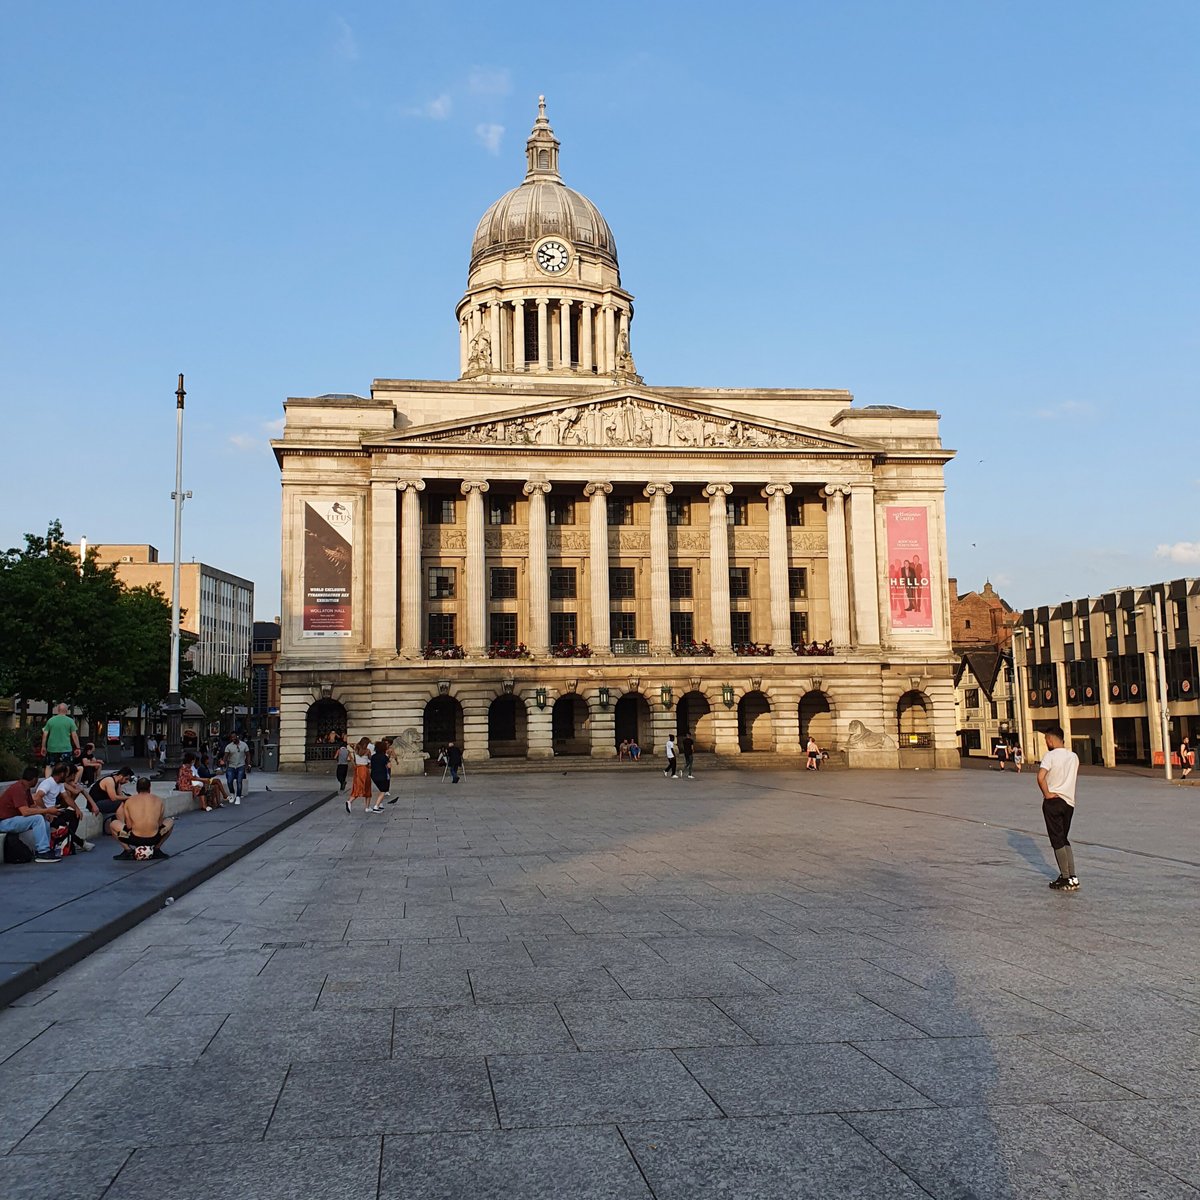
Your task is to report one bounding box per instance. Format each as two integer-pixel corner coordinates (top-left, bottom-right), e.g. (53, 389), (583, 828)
(1013, 580), (1200, 767)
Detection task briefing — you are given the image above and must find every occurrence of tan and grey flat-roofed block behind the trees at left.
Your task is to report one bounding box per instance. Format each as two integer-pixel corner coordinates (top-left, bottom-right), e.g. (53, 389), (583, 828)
(71, 542), (254, 679)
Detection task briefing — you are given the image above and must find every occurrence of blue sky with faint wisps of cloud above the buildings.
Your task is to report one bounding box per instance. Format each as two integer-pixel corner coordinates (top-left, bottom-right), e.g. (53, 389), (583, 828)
(0, 0), (1200, 618)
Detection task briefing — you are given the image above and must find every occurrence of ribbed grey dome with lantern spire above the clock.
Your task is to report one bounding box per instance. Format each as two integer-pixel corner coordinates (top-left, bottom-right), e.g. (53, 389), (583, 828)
(470, 96), (617, 266)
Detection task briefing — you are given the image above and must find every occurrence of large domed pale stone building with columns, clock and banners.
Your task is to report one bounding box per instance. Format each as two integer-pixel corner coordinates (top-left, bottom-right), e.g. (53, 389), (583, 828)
(274, 93), (958, 767)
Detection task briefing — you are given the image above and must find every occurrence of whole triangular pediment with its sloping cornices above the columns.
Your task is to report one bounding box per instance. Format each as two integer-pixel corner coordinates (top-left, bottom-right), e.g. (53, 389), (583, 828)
(371, 388), (877, 454)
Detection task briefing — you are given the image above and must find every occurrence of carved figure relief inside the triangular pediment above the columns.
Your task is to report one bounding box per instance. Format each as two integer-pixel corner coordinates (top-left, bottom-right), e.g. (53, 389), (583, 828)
(436, 396), (829, 449)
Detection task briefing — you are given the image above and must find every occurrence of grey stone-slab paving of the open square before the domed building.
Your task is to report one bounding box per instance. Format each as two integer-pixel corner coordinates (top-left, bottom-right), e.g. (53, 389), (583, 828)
(0, 764), (1200, 1200)
